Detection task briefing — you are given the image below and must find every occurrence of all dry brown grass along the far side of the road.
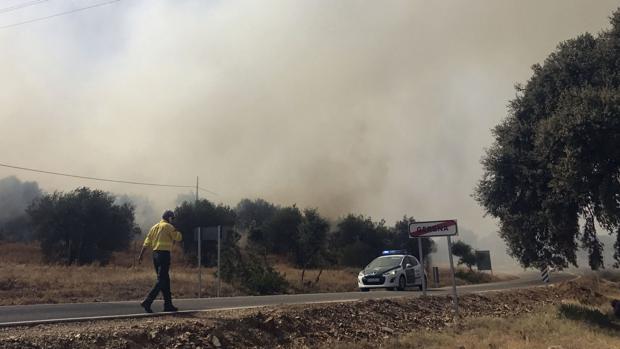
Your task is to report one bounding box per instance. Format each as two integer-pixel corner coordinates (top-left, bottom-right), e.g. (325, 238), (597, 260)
(0, 242), (511, 305)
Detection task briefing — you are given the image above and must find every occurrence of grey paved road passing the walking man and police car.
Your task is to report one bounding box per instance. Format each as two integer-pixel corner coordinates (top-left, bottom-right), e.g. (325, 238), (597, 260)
(0, 273), (576, 327)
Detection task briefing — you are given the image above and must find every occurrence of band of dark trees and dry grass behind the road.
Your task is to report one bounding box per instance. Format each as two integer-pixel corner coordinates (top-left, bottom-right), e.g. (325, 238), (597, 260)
(0, 177), (504, 305)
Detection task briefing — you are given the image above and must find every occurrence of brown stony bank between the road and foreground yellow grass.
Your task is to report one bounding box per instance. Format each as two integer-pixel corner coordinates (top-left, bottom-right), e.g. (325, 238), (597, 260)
(0, 279), (608, 348)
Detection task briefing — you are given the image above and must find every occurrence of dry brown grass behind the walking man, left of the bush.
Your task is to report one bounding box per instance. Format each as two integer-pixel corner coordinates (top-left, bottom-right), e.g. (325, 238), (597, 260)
(0, 243), (242, 305)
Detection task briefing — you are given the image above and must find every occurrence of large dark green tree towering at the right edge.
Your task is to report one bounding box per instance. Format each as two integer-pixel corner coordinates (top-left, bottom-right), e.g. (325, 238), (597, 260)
(474, 12), (620, 269)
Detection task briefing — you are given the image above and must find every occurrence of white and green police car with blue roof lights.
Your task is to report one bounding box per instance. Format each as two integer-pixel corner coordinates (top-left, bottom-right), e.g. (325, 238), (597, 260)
(357, 250), (428, 292)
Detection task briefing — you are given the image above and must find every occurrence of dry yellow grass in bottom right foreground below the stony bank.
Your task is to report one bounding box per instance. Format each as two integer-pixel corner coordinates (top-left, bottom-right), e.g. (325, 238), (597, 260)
(337, 274), (620, 349)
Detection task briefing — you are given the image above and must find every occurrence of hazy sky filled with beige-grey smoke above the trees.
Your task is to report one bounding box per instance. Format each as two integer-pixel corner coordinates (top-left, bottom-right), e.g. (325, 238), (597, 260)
(0, 0), (618, 256)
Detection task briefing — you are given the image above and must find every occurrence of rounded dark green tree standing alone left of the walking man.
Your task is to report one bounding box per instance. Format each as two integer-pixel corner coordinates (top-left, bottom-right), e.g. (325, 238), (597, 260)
(27, 188), (137, 264)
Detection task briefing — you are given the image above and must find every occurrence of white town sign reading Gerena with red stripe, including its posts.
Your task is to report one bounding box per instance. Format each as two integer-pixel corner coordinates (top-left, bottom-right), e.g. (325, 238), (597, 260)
(409, 219), (459, 317)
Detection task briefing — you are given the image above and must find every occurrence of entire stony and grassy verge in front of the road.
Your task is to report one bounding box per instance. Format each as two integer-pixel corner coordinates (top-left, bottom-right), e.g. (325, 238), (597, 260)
(0, 275), (620, 349)
